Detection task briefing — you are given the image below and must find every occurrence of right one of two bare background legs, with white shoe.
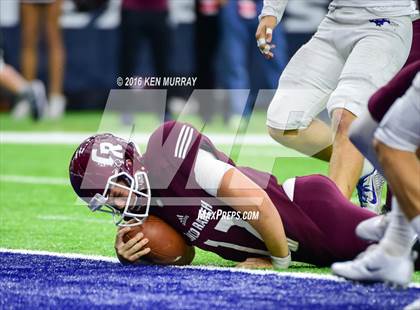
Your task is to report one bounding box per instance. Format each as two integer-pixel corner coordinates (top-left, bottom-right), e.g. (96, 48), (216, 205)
(44, 0), (66, 118)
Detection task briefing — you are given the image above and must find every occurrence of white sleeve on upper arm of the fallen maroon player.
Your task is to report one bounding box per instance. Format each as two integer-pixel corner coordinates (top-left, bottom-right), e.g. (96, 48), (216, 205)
(194, 149), (234, 197)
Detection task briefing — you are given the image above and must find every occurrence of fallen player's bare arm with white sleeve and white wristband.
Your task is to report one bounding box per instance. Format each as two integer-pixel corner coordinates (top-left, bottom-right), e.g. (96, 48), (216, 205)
(194, 150), (290, 268)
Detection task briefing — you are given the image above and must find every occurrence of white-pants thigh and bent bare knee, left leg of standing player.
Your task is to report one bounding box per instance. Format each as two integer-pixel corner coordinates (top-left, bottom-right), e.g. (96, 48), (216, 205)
(267, 36), (344, 161)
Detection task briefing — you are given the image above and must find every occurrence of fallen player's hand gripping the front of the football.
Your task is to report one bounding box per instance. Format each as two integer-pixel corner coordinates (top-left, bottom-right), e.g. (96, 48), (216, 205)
(115, 227), (150, 264)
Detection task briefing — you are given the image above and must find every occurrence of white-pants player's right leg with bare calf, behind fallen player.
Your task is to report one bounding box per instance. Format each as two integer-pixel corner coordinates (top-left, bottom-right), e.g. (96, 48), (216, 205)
(327, 18), (412, 202)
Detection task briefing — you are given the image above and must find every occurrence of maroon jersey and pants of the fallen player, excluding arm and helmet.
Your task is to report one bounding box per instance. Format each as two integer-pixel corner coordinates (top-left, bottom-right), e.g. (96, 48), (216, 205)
(144, 122), (373, 266)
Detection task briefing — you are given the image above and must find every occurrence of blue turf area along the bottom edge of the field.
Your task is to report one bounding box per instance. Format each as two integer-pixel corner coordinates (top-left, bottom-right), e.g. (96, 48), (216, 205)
(0, 252), (420, 309)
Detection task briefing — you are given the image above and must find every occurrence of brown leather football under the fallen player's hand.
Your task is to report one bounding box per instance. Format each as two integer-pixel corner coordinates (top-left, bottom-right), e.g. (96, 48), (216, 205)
(123, 215), (194, 265)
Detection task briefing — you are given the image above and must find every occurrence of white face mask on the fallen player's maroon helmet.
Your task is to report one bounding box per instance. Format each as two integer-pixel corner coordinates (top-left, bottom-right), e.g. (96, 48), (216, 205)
(88, 171), (151, 226)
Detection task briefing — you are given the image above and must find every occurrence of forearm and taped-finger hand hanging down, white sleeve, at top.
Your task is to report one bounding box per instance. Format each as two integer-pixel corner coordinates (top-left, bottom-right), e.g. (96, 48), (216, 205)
(255, 0), (288, 59)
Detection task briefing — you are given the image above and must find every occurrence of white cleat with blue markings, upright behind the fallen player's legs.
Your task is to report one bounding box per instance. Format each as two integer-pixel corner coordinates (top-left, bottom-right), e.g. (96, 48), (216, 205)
(356, 169), (385, 214)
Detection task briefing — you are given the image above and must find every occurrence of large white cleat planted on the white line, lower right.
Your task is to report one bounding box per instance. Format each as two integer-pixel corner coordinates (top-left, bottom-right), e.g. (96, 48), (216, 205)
(331, 245), (415, 287)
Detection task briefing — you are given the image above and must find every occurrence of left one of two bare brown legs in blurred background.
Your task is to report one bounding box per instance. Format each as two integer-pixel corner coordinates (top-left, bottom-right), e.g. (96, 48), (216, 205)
(21, 3), (40, 81)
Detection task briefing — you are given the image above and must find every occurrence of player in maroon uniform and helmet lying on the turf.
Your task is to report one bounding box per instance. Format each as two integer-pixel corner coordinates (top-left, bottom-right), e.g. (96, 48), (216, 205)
(70, 122), (374, 268)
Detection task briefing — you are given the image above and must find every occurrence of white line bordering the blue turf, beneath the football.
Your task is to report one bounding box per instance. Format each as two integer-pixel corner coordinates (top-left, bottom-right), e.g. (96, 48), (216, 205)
(0, 248), (420, 288)
